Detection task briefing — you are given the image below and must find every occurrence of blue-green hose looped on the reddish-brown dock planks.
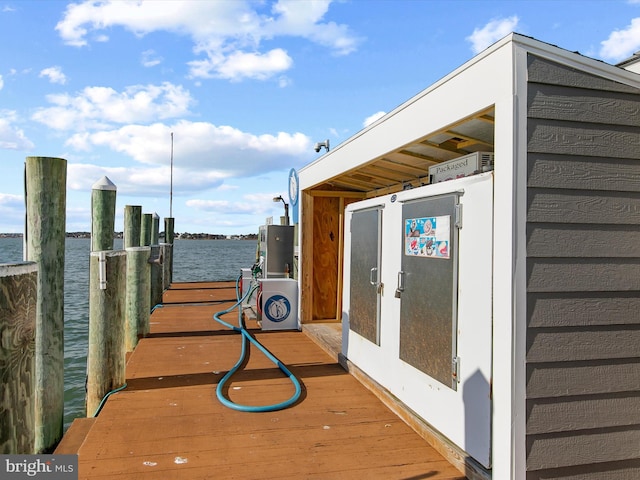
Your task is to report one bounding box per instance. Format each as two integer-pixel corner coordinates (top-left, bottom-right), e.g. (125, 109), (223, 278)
(213, 277), (302, 412)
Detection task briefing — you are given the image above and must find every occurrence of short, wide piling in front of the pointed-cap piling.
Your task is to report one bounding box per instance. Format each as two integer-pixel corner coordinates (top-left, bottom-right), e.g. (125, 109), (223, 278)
(86, 251), (126, 417)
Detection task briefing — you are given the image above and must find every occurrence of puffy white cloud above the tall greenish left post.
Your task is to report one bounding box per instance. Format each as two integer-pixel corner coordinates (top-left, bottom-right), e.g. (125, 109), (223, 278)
(32, 82), (193, 131)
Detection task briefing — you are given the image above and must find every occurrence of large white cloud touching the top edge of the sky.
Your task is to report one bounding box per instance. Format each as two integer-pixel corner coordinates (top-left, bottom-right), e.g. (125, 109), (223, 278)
(56, 0), (361, 80)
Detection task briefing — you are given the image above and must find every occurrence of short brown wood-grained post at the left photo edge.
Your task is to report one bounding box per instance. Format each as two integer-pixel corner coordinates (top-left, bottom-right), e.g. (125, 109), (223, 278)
(0, 262), (38, 454)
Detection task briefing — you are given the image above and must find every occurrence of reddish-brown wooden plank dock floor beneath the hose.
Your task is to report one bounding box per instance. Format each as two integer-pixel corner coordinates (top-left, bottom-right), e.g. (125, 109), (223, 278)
(56, 283), (465, 480)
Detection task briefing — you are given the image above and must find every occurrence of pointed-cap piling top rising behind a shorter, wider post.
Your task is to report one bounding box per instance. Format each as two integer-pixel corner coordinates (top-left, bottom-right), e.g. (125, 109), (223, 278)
(91, 177), (117, 252)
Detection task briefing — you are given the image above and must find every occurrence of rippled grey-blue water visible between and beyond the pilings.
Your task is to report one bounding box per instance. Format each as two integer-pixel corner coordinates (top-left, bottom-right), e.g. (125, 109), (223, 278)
(0, 238), (256, 430)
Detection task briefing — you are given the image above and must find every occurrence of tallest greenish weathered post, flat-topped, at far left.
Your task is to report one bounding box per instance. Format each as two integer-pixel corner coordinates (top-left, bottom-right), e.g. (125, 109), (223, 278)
(24, 157), (67, 453)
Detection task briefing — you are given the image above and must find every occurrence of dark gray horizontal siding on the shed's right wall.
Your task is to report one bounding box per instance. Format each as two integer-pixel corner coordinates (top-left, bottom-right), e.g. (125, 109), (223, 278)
(526, 55), (640, 480)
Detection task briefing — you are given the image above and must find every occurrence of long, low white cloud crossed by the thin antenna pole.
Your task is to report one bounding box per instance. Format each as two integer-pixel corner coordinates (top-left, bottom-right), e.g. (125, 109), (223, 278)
(66, 120), (311, 179)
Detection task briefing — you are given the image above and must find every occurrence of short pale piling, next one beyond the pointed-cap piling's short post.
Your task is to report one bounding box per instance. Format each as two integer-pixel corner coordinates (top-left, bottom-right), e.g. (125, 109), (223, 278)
(125, 247), (151, 352)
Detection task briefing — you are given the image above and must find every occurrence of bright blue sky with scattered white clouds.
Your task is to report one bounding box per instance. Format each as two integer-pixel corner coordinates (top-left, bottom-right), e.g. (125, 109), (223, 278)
(0, 0), (640, 235)
